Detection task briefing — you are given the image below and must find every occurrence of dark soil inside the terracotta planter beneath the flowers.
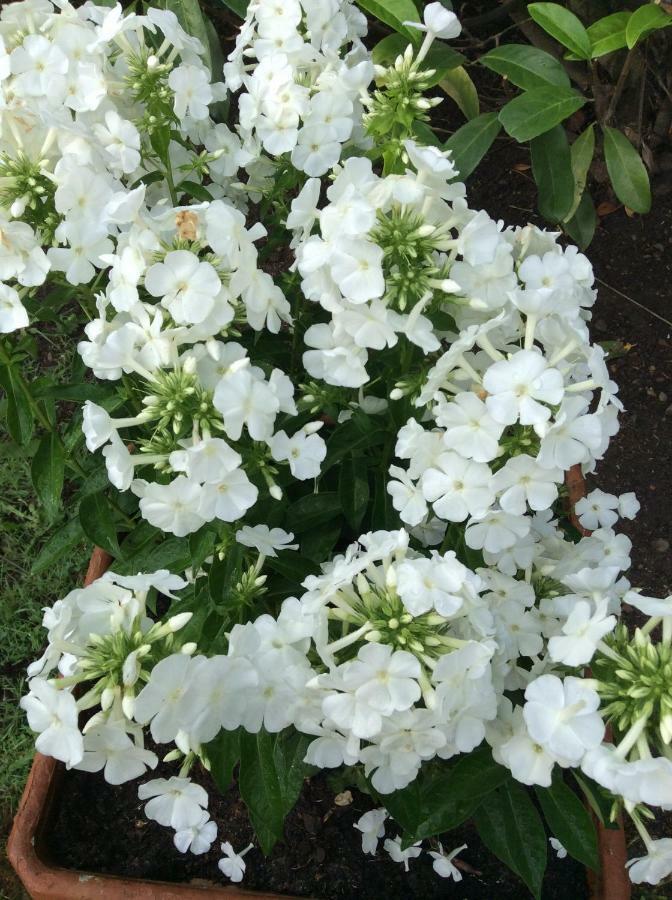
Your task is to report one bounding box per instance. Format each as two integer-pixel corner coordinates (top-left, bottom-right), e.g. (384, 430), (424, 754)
(44, 765), (588, 900)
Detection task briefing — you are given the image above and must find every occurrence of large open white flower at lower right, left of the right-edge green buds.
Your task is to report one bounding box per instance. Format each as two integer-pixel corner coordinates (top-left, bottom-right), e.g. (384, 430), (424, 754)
(523, 675), (604, 766)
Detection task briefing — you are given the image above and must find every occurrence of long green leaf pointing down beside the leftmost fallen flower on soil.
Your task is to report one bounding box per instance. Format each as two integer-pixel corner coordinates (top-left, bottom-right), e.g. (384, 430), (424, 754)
(238, 729), (312, 855)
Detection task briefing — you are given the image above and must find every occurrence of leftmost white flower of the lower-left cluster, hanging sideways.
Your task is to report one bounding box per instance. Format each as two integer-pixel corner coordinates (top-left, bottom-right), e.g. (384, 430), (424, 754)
(20, 678), (84, 767)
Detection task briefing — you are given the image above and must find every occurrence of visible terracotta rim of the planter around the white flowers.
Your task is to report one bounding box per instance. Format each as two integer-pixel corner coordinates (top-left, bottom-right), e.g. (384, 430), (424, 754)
(7, 486), (631, 900)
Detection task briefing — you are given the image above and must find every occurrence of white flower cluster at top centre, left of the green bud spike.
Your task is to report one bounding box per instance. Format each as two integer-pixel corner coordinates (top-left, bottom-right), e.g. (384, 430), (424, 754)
(224, 0), (373, 176)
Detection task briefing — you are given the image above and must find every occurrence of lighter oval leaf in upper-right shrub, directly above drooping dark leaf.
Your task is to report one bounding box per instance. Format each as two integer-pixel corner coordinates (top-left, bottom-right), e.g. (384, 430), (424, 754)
(499, 86), (586, 143)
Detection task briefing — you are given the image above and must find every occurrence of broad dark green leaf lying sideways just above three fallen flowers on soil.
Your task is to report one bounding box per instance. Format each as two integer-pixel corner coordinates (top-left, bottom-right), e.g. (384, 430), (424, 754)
(381, 747), (510, 843)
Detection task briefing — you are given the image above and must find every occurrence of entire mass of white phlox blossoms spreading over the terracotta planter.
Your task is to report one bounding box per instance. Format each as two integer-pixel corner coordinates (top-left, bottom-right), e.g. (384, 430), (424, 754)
(14, 0), (672, 880)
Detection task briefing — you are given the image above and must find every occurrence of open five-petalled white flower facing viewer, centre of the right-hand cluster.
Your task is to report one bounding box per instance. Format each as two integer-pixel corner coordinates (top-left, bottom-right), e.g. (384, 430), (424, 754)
(483, 350), (564, 425)
